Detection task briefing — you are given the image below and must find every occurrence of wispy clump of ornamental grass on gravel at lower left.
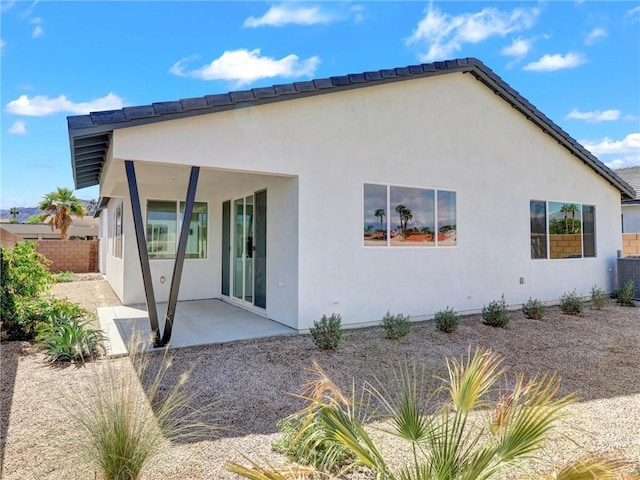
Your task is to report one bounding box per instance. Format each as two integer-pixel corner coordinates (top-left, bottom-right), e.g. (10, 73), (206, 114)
(67, 341), (216, 480)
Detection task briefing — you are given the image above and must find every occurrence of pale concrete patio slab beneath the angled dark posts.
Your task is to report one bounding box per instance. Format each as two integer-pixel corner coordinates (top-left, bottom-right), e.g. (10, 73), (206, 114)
(98, 299), (297, 356)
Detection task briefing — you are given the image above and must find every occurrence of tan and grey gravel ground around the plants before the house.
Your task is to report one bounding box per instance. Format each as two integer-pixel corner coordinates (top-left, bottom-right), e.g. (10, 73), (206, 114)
(0, 279), (640, 480)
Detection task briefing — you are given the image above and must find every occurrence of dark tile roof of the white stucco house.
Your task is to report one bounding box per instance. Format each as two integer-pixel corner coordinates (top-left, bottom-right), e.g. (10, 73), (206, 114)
(67, 58), (635, 198)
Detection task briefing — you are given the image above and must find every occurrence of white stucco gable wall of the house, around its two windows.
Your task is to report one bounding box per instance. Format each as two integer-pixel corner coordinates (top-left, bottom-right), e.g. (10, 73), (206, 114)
(110, 74), (621, 329)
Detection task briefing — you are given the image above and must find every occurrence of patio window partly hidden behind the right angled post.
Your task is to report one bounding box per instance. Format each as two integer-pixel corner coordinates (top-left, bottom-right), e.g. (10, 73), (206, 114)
(147, 200), (207, 259)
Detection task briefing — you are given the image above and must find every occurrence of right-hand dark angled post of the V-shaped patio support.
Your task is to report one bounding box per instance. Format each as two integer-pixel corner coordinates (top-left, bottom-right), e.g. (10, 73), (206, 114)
(160, 167), (200, 346)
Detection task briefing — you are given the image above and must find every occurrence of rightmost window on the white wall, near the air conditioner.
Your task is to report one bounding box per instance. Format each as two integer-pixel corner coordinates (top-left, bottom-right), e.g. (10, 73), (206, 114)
(529, 200), (596, 259)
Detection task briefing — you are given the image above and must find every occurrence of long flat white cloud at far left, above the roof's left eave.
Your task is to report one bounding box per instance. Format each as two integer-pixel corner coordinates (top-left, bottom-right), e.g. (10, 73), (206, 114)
(5, 93), (124, 117)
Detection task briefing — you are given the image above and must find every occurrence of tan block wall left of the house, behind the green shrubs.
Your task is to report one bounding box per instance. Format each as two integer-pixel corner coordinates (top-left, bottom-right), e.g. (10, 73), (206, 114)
(36, 240), (98, 273)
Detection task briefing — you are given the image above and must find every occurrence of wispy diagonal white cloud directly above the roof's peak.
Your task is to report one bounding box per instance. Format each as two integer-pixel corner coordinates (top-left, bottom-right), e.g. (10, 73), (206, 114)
(406, 4), (539, 62)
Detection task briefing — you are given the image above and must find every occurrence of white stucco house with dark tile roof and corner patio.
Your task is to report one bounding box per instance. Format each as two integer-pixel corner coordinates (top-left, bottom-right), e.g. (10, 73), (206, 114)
(68, 58), (635, 344)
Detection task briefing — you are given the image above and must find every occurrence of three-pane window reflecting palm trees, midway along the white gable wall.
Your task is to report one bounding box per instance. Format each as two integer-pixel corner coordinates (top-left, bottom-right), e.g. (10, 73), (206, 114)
(363, 183), (457, 247)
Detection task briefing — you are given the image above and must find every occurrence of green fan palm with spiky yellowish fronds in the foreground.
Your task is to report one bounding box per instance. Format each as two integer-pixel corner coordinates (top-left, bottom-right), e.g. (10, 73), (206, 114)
(227, 348), (592, 480)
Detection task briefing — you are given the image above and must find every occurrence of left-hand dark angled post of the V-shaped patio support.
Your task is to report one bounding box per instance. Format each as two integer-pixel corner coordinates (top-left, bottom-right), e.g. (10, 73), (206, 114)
(124, 160), (160, 347)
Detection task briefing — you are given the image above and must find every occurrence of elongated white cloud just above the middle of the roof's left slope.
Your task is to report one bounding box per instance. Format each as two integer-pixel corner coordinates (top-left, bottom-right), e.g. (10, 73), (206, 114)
(169, 48), (320, 87)
